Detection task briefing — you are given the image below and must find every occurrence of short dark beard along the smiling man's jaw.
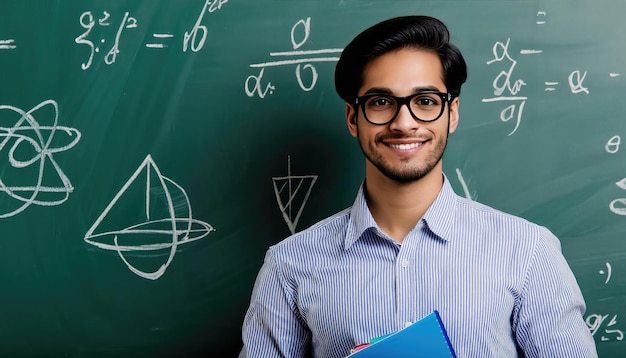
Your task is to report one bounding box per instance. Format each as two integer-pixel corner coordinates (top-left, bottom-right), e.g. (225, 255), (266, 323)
(357, 127), (448, 183)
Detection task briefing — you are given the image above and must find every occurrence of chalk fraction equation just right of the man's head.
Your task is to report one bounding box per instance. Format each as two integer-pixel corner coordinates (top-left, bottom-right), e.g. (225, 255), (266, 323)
(482, 11), (589, 136)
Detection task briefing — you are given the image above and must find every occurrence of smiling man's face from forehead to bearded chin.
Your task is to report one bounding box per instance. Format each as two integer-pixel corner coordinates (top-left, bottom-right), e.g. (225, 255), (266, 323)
(346, 49), (459, 183)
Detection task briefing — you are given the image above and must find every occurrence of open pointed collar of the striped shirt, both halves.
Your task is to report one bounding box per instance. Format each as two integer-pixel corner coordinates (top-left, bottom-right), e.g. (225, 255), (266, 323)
(344, 175), (458, 249)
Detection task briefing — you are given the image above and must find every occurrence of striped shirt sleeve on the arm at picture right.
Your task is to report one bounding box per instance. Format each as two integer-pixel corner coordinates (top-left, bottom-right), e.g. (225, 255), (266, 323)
(513, 228), (598, 358)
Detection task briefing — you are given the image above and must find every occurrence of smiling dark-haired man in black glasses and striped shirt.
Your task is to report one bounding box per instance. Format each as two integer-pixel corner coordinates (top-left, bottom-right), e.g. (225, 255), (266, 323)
(241, 16), (597, 358)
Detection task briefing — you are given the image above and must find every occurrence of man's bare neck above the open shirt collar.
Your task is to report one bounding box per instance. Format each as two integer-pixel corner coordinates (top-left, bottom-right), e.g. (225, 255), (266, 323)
(365, 166), (443, 243)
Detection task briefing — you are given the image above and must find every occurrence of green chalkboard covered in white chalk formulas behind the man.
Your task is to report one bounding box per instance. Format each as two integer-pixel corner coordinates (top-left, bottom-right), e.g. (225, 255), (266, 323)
(0, 0), (626, 358)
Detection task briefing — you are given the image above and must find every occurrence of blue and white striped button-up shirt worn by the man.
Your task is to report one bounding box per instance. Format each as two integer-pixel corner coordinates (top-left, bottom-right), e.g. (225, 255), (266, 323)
(241, 179), (597, 358)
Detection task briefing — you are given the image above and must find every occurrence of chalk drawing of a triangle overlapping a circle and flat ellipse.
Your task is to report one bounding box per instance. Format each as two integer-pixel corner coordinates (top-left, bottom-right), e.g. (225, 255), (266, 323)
(84, 155), (215, 280)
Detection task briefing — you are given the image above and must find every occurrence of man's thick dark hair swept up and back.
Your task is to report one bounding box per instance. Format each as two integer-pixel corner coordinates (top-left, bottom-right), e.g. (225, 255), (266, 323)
(335, 16), (467, 104)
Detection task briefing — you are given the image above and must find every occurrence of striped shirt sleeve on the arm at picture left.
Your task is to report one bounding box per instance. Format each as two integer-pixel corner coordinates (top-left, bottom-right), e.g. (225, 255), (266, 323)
(240, 248), (311, 358)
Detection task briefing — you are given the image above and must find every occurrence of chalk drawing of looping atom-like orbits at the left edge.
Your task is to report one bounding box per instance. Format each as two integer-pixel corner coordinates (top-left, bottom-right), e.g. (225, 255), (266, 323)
(0, 100), (81, 218)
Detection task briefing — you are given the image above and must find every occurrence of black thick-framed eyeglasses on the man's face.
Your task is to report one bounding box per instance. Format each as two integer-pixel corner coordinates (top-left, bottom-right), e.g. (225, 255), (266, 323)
(354, 91), (454, 125)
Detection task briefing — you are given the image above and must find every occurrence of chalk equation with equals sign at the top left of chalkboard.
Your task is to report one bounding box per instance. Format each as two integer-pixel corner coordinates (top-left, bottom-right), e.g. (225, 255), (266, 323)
(74, 0), (228, 70)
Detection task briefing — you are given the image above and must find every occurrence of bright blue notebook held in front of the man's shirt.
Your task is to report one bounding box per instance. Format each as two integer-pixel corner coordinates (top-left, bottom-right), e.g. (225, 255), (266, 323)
(348, 311), (456, 358)
